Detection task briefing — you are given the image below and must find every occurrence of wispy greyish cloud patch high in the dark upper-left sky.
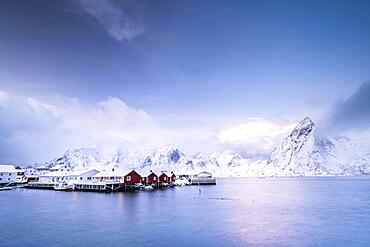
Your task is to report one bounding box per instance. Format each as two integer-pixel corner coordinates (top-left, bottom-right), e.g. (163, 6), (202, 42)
(78, 0), (144, 41)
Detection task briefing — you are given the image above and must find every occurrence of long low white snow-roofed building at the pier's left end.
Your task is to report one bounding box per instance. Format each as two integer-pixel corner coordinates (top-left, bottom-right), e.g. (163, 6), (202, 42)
(39, 169), (99, 183)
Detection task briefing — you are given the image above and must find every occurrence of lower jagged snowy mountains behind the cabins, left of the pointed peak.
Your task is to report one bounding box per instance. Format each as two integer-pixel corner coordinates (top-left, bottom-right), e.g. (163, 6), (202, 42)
(39, 144), (254, 176)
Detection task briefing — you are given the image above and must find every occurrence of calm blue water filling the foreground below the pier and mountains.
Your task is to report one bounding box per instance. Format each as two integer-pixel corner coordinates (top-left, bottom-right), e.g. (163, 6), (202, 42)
(0, 178), (370, 247)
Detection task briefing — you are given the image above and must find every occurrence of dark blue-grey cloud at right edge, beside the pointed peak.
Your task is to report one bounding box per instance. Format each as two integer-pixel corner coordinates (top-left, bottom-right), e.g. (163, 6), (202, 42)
(329, 81), (370, 129)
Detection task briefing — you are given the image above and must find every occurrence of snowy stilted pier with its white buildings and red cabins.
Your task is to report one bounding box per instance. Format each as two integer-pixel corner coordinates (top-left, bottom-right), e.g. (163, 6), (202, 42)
(24, 169), (216, 192)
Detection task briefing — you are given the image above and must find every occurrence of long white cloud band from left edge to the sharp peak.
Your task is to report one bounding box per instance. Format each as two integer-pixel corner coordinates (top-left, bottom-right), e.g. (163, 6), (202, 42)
(0, 91), (292, 164)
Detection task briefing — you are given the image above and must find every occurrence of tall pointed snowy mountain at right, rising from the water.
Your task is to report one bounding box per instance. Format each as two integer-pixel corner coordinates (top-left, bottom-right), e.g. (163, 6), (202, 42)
(264, 117), (370, 176)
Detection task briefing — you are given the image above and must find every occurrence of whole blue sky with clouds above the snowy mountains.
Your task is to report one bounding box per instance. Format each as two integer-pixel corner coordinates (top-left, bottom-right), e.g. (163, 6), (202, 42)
(0, 0), (370, 163)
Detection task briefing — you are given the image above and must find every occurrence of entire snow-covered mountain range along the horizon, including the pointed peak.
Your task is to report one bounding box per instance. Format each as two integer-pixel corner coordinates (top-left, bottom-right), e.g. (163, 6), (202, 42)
(36, 118), (370, 177)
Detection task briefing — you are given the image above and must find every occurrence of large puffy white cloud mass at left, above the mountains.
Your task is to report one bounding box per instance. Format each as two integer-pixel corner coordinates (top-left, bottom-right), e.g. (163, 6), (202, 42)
(0, 91), (163, 163)
